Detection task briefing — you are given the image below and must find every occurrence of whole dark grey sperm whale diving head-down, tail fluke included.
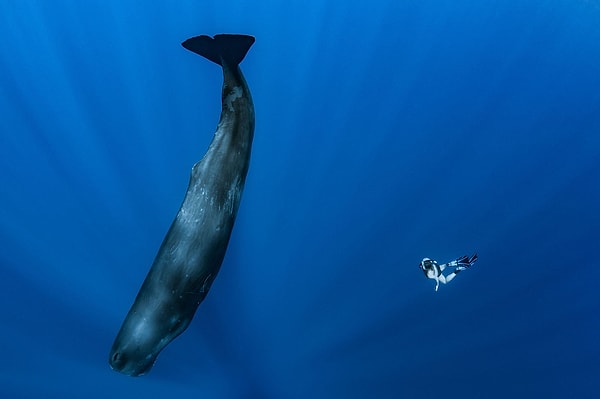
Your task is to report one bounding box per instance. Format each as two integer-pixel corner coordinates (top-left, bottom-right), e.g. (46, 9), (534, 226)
(109, 35), (254, 376)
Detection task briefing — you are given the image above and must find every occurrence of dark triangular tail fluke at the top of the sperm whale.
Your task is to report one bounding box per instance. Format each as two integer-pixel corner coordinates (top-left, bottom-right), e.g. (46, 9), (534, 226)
(181, 35), (254, 66)
